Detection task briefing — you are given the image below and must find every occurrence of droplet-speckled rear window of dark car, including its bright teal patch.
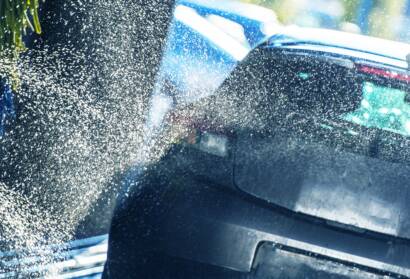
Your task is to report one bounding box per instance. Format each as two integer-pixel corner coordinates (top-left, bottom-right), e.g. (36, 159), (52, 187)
(282, 61), (410, 139)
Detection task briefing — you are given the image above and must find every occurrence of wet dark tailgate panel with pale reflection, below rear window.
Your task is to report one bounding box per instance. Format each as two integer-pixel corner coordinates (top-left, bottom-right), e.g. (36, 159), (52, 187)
(235, 131), (410, 239)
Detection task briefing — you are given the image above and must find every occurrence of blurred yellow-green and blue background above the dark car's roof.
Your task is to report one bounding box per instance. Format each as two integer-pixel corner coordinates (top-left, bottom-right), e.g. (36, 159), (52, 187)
(241, 0), (410, 42)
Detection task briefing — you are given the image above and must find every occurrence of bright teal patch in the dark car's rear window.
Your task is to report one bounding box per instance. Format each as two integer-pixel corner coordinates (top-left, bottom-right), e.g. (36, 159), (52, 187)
(343, 81), (410, 136)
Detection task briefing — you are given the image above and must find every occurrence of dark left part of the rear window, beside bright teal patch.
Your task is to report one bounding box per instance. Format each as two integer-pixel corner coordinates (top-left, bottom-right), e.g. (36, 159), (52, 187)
(271, 56), (361, 118)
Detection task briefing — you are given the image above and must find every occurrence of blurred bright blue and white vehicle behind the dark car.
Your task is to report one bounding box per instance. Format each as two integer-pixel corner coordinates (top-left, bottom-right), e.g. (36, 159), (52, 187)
(157, 0), (278, 106)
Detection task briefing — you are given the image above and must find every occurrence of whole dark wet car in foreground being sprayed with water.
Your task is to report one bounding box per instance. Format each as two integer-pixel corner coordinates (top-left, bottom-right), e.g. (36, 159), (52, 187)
(105, 28), (410, 279)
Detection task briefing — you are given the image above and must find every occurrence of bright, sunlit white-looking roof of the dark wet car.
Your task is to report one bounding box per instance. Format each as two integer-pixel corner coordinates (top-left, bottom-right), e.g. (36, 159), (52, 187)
(267, 27), (410, 68)
